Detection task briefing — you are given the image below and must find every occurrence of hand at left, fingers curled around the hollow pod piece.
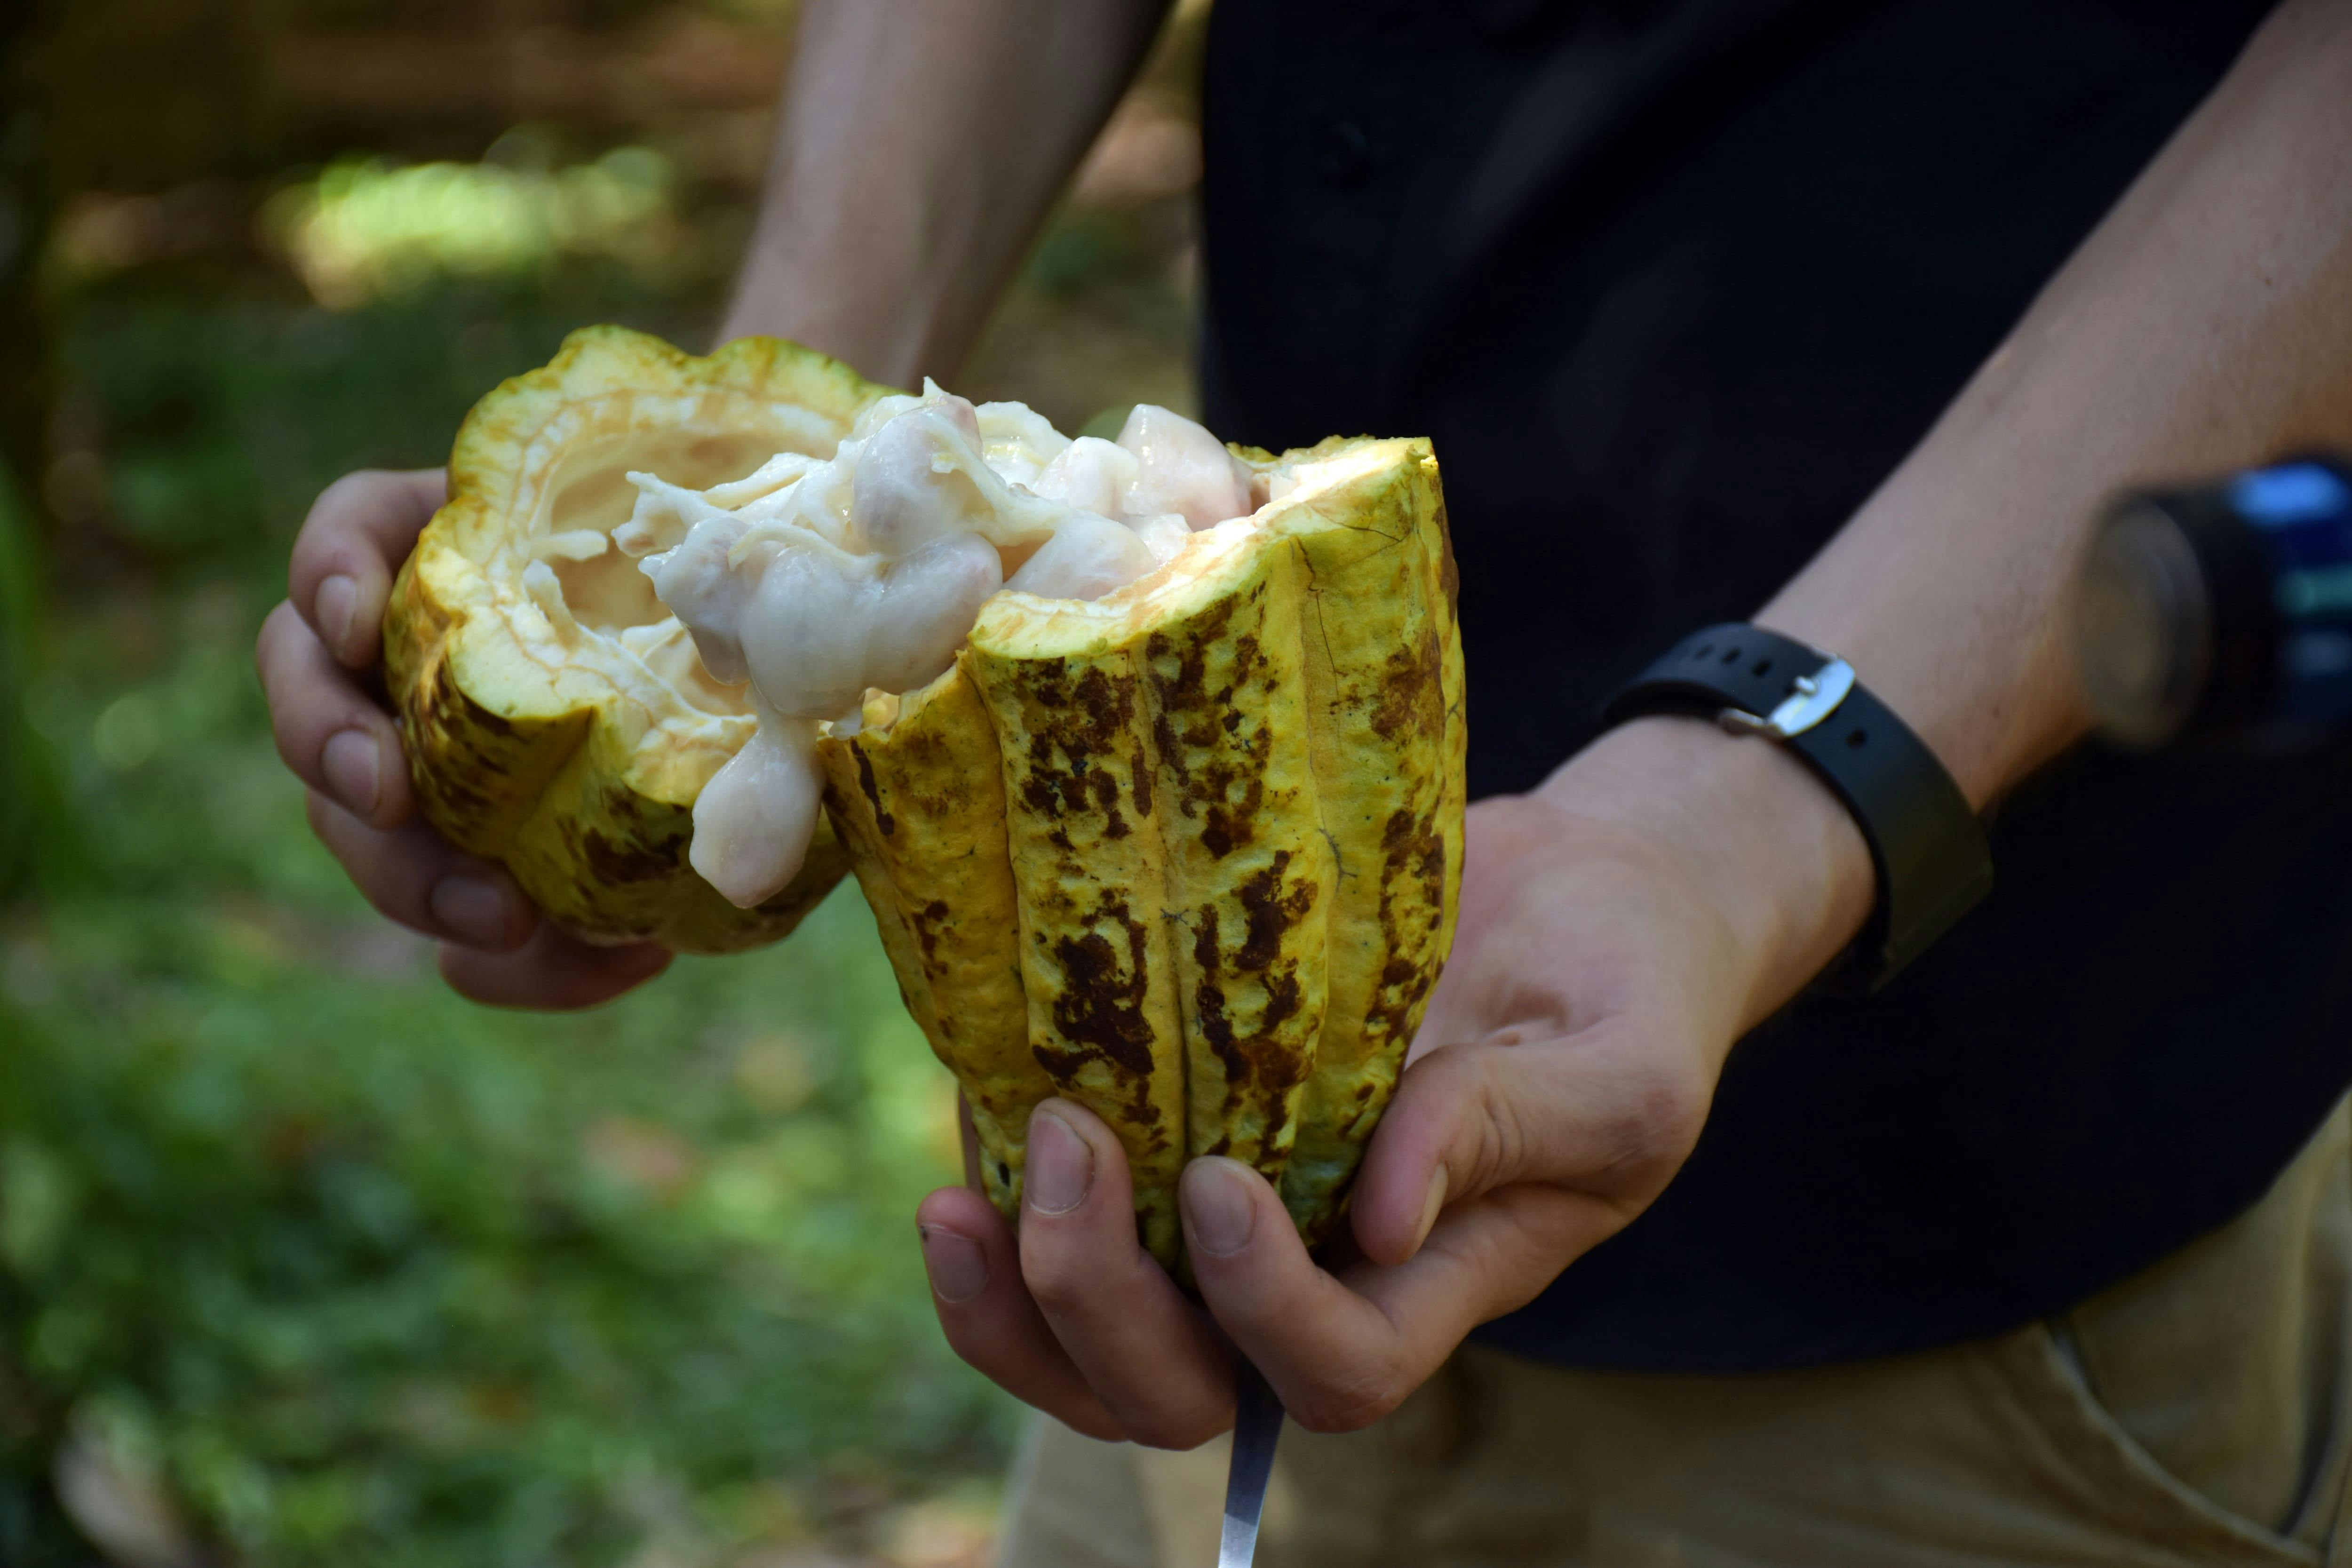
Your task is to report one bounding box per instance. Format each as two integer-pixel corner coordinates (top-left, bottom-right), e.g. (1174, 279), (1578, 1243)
(254, 468), (670, 1009)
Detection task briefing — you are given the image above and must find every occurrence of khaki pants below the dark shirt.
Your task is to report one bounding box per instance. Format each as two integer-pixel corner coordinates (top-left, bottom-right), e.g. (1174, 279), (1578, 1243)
(1000, 1105), (2352, 1568)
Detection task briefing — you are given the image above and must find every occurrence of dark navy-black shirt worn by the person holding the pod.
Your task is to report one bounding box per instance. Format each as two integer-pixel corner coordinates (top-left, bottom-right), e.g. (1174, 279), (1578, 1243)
(1204, 0), (2352, 1370)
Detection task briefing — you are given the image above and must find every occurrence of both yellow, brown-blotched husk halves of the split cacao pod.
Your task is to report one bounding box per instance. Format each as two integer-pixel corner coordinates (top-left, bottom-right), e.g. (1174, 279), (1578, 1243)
(386, 327), (1465, 1267)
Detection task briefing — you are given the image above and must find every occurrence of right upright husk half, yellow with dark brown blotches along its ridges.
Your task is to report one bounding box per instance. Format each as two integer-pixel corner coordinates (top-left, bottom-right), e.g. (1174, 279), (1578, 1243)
(818, 439), (1465, 1265)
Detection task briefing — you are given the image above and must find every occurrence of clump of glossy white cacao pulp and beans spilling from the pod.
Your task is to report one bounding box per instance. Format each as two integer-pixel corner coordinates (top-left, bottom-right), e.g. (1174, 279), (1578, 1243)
(612, 381), (1263, 907)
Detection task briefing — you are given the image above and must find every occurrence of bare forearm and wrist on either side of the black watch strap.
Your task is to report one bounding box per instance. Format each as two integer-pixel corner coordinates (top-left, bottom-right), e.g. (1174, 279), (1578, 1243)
(1545, 0), (2352, 1025)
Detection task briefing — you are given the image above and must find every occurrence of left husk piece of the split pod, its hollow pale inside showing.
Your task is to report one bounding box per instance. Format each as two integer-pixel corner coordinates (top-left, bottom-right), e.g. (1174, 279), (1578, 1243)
(383, 327), (889, 952)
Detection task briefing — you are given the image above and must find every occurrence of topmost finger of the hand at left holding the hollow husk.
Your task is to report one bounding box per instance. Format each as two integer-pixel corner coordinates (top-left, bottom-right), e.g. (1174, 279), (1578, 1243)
(287, 468), (449, 670)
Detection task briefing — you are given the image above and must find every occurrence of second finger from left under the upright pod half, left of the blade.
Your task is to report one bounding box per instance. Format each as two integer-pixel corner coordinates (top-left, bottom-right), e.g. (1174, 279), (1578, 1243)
(1011, 1100), (1232, 1448)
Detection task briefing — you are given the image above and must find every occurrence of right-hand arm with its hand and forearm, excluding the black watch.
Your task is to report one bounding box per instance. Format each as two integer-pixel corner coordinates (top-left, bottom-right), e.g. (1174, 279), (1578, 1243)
(898, 0), (2352, 1446)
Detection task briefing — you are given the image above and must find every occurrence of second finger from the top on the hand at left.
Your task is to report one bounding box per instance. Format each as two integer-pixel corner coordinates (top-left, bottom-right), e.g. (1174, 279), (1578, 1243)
(254, 602), (416, 828)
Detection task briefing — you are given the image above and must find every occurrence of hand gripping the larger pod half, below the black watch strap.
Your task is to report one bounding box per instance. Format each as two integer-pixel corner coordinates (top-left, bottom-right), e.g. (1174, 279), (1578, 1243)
(917, 719), (1870, 1448)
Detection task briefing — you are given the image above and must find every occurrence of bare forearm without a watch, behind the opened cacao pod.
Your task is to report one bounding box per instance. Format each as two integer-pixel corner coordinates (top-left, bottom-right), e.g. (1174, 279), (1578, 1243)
(720, 0), (1167, 386)
